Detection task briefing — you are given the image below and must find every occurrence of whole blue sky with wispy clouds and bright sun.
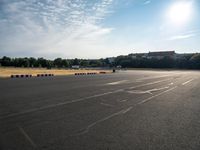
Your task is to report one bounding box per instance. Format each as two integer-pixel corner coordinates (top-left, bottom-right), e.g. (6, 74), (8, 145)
(0, 0), (200, 58)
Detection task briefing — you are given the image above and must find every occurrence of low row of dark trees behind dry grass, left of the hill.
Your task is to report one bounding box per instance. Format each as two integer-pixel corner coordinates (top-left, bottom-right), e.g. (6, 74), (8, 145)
(0, 56), (110, 68)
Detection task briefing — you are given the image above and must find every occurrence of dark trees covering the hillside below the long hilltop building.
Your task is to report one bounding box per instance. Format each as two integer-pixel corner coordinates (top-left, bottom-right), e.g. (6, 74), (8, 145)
(115, 53), (200, 69)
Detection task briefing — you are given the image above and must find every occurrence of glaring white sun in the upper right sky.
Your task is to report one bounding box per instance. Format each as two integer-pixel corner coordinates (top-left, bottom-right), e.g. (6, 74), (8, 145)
(167, 1), (193, 26)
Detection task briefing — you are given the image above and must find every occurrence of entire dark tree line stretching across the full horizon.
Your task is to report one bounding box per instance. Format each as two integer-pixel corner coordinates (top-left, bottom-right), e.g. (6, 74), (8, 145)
(0, 53), (200, 69)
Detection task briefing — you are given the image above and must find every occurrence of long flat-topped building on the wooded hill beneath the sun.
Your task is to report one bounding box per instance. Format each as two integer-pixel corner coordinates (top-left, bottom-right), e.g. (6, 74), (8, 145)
(147, 51), (176, 59)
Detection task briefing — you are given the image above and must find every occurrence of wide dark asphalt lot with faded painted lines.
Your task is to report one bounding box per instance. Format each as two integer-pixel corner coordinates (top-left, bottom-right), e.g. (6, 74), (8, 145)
(0, 70), (200, 150)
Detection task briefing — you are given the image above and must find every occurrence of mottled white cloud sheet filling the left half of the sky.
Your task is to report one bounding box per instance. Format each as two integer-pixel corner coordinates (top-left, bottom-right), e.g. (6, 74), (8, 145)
(0, 0), (113, 57)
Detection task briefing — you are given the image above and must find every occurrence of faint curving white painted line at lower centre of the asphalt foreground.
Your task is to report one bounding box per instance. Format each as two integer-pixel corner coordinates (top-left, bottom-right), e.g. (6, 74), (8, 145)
(75, 106), (133, 136)
